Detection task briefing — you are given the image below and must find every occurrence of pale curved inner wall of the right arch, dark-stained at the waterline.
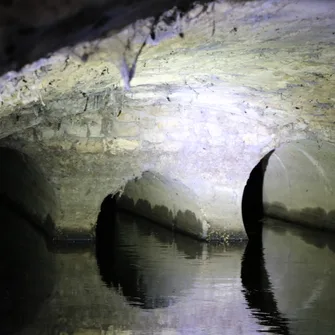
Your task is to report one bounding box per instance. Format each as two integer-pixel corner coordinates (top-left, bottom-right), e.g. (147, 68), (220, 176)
(263, 140), (335, 231)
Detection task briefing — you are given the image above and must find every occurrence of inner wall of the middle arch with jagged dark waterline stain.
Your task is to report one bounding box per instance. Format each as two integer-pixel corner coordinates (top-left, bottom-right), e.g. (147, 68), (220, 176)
(117, 171), (208, 240)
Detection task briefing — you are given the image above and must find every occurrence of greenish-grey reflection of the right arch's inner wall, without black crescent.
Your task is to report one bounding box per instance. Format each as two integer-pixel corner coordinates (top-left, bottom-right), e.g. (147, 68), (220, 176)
(263, 220), (335, 335)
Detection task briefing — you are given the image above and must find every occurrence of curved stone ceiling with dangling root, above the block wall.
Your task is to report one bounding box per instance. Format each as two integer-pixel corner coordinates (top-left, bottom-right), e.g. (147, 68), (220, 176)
(0, 0), (335, 136)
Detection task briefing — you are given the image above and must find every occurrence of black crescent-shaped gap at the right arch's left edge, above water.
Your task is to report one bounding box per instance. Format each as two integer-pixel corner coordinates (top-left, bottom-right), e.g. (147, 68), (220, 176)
(242, 150), (274, 240)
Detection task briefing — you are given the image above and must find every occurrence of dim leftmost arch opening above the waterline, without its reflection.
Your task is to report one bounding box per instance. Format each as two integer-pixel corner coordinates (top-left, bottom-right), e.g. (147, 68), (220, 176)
(0, 147), (58, 238)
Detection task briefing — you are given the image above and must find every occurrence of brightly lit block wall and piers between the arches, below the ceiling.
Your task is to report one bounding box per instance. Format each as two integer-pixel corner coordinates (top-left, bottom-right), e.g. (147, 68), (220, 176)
(3, 96), (255, 237)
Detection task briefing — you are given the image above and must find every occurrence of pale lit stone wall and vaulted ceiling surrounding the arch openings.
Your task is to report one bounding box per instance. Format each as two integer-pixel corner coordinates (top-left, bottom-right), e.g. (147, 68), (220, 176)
(0, 0), (335, 235)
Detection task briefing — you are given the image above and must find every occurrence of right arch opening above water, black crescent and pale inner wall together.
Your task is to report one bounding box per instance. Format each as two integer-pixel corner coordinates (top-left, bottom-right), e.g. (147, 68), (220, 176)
(242, 140), (335, 237)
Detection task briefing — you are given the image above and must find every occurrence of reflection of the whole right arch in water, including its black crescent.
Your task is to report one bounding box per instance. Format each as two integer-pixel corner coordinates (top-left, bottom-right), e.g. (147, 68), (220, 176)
(241, 219), (335, 335)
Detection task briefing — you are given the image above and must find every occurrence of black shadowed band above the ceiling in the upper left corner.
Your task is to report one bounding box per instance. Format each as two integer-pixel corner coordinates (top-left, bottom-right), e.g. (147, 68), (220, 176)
(0, 0), (253, 76)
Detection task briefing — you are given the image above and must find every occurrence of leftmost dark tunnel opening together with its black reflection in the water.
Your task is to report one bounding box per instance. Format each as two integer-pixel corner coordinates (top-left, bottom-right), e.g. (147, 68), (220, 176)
(0, 147), (55, 334)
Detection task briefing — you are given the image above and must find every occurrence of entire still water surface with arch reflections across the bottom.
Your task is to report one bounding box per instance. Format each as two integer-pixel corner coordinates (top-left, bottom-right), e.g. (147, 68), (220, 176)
(0, 206), (335, 335)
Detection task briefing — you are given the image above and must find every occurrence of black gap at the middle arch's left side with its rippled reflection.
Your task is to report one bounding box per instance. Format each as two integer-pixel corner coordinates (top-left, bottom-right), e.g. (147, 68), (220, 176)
(95, 194), (173, 309)
